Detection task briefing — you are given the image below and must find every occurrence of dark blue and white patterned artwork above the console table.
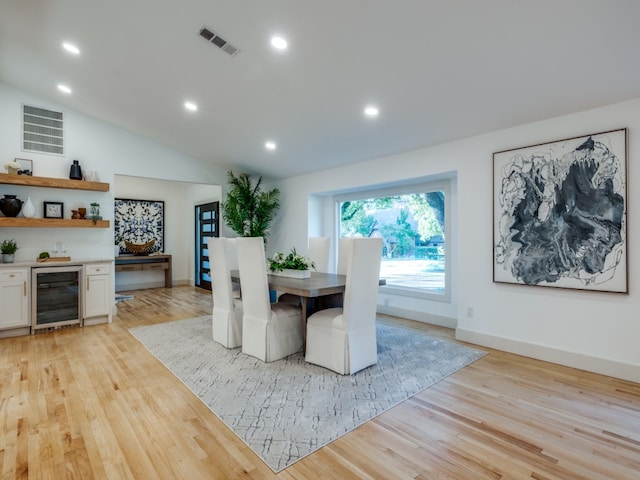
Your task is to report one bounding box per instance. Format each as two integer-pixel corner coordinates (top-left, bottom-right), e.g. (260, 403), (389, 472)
(114, 198), (164, 254)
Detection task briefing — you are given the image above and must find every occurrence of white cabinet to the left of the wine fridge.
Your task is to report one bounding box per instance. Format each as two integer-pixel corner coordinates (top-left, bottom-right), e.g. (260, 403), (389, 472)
(0, 268), (31, 337)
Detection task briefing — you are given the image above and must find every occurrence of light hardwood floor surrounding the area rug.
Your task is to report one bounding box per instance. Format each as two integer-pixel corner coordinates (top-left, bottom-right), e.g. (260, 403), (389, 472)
(0, 287), (640, 480)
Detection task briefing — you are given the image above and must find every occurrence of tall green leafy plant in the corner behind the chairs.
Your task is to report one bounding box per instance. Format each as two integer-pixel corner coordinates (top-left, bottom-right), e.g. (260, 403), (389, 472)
(222, 171), (280, 240)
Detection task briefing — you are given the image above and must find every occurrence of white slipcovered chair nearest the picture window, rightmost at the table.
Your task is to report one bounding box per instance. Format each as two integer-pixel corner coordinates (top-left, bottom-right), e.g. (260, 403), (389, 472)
(305, 238), (382, 375)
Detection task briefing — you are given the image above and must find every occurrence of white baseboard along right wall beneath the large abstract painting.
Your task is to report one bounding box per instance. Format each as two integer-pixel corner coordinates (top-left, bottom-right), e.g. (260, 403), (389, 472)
(456, 328), (640, 383)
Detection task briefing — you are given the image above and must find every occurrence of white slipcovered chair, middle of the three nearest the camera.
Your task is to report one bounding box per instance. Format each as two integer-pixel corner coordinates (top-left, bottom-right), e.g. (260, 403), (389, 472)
(236, 237), (303, 362)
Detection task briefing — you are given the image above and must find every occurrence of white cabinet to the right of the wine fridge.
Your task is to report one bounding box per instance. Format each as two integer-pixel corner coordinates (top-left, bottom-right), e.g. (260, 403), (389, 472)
(84, 263), (113, 325)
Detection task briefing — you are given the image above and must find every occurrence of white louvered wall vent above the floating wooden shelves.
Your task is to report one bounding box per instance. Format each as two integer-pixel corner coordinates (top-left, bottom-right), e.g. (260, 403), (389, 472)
(22, 105), (64, 155)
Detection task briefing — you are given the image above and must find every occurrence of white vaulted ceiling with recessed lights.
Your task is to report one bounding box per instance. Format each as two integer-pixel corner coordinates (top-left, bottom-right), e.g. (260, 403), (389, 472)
(0, 0), (640, 178)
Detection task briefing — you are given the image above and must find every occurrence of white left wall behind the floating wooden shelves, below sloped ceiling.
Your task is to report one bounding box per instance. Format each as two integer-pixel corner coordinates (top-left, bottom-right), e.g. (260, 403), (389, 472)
(0, 82), (226, 284)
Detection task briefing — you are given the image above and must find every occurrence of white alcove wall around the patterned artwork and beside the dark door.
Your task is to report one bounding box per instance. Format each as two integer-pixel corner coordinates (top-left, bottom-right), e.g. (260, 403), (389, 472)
(113, 175), (221, 291)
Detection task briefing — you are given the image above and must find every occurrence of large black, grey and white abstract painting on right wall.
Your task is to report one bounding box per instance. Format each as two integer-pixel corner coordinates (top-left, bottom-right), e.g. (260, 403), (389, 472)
(493, 129), (628, 293)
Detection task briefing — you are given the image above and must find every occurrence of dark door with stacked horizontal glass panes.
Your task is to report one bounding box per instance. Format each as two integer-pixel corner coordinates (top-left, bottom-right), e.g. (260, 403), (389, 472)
(195, 202), (220, 290)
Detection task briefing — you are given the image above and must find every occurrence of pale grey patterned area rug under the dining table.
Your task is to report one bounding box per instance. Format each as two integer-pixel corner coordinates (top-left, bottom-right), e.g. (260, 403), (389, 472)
(130, 316), (485, 473)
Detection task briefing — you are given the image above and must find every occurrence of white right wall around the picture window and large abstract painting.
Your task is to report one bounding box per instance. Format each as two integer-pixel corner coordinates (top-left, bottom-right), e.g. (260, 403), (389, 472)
(269, 100), (640, 381)
